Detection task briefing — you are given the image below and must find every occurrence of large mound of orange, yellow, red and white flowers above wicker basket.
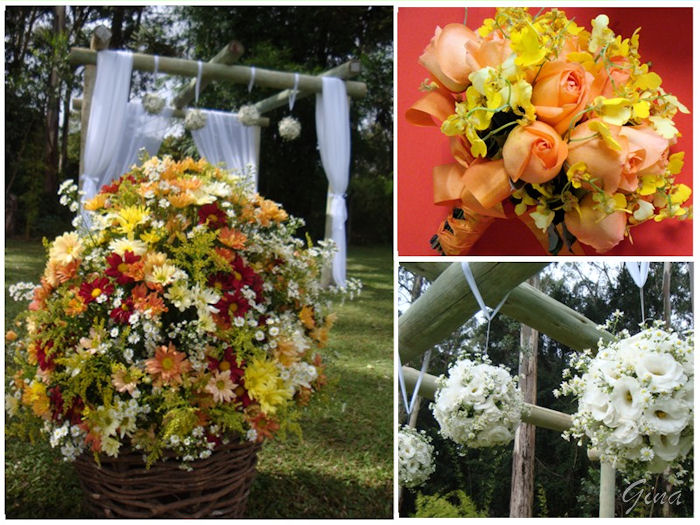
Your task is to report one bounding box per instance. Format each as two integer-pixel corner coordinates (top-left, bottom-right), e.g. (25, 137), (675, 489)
(8, 157), (360, 516)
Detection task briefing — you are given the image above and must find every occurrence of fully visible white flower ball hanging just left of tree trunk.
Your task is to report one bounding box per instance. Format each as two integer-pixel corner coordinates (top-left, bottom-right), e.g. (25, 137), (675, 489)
(431, 359), (523, 448)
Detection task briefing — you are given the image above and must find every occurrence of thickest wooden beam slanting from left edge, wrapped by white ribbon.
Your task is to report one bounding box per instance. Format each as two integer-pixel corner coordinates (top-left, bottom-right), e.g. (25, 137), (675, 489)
(399, 262), (547, 362)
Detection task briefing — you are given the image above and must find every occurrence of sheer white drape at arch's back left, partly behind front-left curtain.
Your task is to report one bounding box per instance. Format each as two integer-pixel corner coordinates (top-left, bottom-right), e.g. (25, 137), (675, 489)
(109, 102), (173, 180)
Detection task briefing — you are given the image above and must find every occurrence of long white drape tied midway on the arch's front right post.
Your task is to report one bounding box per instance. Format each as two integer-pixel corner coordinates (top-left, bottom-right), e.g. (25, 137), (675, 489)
(316, 77), (350, 286)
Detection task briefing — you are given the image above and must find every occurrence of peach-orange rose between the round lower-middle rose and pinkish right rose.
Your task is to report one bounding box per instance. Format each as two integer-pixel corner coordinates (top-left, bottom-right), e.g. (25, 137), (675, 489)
(567, 119), (628, 194)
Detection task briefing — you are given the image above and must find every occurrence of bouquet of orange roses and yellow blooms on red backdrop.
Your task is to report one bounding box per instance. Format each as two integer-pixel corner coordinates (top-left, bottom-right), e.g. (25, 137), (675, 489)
(406, 8), (692, 255)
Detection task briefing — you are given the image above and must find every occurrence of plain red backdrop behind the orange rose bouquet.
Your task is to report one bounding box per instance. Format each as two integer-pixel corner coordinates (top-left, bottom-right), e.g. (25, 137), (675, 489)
(396, 7), (693, 256)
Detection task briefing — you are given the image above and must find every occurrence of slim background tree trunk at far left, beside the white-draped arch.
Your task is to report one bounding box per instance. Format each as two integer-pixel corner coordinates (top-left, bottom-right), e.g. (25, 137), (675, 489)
(44, 5), (66, 194)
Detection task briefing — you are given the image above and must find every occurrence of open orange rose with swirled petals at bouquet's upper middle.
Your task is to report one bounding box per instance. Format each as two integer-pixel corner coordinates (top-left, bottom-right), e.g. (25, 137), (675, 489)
(532, 60), (593, 135)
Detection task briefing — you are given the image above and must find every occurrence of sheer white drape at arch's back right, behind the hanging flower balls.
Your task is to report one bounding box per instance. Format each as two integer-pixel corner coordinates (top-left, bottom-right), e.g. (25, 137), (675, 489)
(192, 110), (260, 190)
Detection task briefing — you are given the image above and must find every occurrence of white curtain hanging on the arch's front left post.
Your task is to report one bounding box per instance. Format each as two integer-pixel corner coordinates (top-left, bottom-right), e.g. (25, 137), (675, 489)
(82, 51), (132, 200)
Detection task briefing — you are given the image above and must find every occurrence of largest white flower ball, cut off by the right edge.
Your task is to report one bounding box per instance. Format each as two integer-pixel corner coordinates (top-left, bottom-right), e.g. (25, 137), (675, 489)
(554, 323), (694, 482)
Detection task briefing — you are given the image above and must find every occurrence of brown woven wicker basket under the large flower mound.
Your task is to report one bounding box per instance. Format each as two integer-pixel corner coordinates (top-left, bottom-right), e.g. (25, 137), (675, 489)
(74, 443), (260, 518)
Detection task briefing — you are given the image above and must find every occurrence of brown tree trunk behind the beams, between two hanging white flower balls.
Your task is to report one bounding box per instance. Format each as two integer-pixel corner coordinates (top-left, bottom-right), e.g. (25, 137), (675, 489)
(510, 276), (539, 518)
